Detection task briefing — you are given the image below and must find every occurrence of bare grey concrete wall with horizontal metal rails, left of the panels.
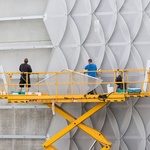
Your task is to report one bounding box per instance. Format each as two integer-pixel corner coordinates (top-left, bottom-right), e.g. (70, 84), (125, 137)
(0, 0), (52, 150)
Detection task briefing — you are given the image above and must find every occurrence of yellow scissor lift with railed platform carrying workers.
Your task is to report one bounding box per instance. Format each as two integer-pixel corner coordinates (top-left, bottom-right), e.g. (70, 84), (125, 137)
(0, 69), (150, 150)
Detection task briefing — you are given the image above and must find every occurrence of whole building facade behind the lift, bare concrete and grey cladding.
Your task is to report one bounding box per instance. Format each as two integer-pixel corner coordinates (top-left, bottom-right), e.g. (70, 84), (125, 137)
(0, 0), (150, 150)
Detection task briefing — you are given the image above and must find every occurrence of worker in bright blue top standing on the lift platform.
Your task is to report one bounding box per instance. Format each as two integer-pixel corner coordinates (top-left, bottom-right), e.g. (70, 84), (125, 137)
(84, 59), (97, 94)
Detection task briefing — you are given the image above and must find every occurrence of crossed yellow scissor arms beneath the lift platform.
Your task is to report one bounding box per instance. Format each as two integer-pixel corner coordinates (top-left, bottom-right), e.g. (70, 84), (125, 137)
(42, 102), (111, 150)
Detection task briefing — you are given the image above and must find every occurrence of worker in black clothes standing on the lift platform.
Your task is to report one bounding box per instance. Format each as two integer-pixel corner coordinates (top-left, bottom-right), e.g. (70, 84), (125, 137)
(19, 58), (32, 92)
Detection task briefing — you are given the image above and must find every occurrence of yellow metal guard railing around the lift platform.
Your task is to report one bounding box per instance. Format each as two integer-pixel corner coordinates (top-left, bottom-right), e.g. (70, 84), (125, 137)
(0, 69), (150, 96)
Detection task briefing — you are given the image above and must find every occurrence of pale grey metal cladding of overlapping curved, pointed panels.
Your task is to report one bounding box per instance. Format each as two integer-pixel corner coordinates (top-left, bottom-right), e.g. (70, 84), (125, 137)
(44, 0), (150, 150)
